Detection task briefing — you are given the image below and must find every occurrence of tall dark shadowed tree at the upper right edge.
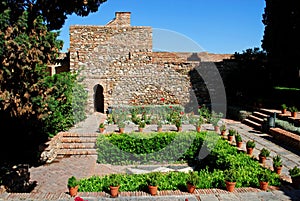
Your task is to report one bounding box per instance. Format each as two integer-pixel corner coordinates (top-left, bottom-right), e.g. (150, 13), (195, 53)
(262, 0), (300, 84)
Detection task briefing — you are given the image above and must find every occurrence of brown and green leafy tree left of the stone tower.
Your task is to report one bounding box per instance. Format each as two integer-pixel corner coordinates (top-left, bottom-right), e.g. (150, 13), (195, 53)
(0, 5), (86, 164)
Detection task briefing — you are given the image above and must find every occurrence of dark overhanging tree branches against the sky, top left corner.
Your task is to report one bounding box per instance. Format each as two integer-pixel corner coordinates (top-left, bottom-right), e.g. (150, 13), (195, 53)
(0, 0), (106, 30)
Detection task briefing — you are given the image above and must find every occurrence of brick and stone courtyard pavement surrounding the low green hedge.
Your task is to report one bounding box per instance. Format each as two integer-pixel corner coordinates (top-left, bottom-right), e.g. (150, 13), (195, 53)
(0, 113), (300, 201)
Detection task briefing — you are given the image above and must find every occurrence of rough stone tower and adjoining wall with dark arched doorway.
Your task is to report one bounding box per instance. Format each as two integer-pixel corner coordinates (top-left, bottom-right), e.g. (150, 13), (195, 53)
(69, 12), (231, 113)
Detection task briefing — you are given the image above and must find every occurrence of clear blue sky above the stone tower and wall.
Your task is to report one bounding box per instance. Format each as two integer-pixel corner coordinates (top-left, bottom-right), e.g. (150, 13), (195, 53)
(59, 0), (265, 54)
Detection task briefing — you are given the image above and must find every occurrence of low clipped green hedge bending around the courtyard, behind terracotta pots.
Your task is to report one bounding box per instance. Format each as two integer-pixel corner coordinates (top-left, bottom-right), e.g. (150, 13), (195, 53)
(84, 132), (280, 192)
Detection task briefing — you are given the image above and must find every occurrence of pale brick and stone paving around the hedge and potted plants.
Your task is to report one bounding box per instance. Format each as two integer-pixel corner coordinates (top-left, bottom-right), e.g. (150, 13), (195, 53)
(0, 114), (300, 201)
